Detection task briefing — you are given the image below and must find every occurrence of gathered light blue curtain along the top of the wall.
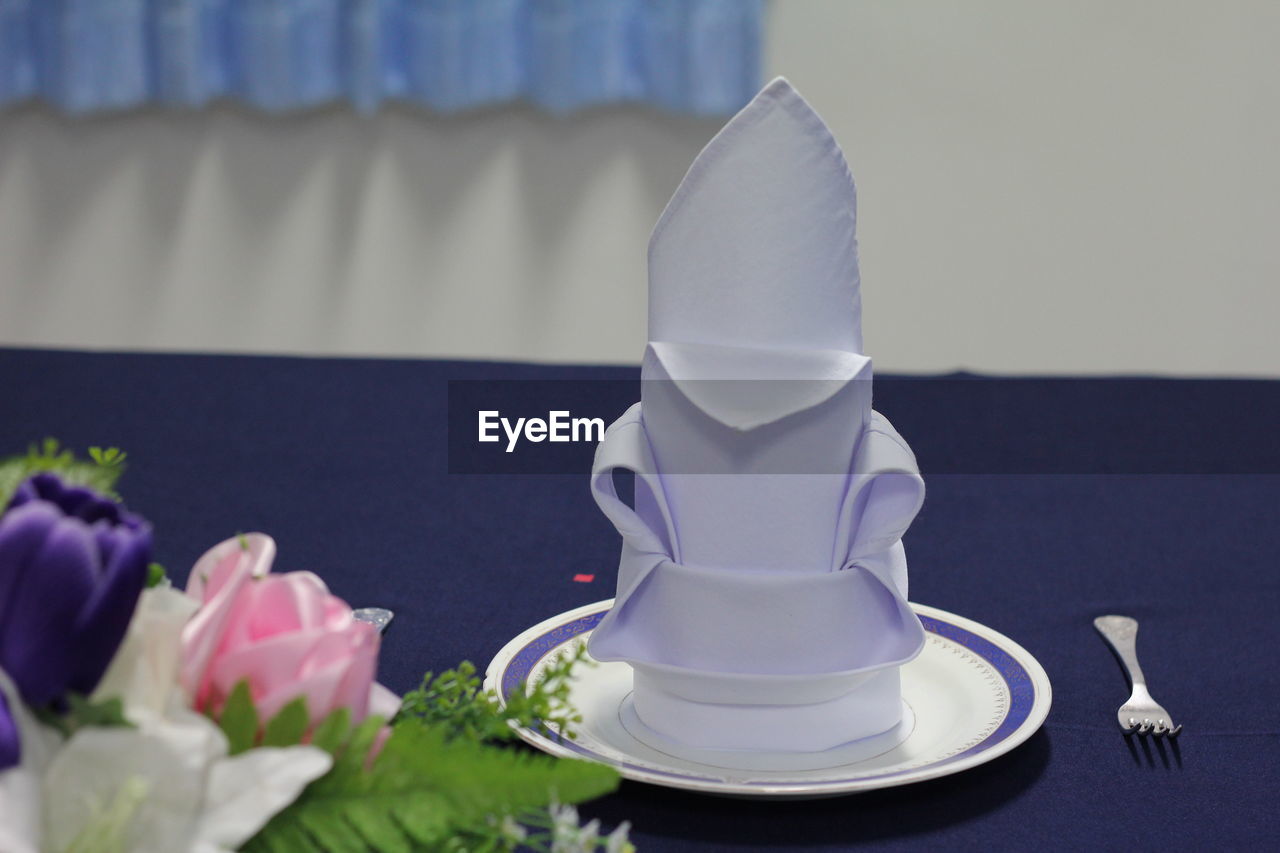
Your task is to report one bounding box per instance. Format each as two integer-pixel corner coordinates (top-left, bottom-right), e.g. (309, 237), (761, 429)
(0, 0), (763, 114)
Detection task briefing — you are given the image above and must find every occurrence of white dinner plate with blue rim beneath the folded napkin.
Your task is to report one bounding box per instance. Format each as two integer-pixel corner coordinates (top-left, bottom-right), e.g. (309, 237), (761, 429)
(485, 599), (1051, 798)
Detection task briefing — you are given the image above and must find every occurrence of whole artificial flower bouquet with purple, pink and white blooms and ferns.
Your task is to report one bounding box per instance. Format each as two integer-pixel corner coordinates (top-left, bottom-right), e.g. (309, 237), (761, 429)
(0, 441), (631, 853)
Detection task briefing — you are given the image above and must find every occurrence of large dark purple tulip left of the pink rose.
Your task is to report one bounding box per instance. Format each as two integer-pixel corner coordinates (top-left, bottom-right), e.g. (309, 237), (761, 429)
(0, 474), (151, 768)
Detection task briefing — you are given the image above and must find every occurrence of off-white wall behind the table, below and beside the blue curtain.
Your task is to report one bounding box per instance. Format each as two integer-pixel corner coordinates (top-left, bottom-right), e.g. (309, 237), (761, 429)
(0, 0), (1280, 375)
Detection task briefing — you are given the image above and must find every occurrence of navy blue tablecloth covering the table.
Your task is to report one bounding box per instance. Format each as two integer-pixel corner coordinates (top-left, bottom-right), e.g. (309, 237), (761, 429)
(0, 350), (1280, 850)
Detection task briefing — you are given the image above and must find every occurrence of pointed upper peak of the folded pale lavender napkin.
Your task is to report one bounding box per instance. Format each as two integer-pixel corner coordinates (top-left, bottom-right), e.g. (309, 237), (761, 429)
(649, 77), (863, 353)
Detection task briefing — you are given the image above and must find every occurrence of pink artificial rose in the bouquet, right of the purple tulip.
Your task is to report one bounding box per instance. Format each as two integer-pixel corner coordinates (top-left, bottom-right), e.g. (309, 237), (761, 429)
(182, 533), (393, 724)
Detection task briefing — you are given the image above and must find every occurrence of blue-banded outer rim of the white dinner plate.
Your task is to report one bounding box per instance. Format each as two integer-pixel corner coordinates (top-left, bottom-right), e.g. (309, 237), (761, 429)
(490, 601), (1050, 792)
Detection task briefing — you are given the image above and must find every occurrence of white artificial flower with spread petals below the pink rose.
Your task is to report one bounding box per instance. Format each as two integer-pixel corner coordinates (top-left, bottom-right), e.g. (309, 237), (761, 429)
(41, 587), (333, 853)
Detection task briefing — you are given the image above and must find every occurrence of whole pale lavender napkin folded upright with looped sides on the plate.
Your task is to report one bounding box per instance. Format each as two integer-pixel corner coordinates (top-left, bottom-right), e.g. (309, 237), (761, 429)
(590, 78), (924, 752)
